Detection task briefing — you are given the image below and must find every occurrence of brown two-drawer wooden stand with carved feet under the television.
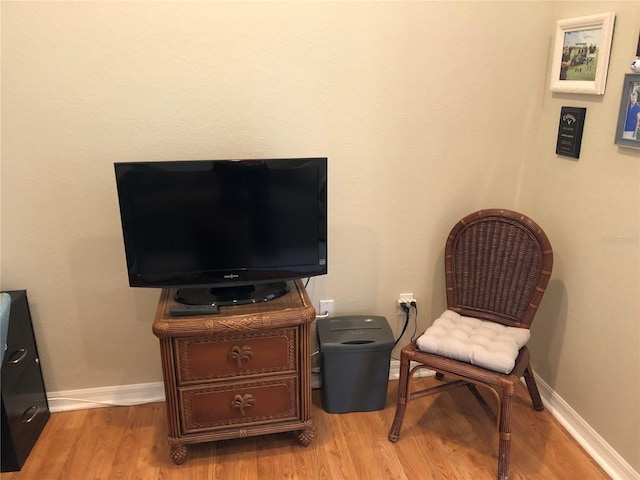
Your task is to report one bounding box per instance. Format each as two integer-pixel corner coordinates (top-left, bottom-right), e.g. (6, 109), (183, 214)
(153, 280), (315, 465)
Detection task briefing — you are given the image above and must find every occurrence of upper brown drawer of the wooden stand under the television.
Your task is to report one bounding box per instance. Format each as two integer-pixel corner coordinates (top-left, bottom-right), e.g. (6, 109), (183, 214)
(175, 328), (298, 385)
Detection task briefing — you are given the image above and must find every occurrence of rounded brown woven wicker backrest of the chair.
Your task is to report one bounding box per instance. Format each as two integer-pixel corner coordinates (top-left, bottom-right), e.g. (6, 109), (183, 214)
(445, 209), (553, 328)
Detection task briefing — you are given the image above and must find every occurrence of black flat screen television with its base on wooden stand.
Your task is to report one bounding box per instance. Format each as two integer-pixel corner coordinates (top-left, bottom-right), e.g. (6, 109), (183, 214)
(114, 158), (327, 314)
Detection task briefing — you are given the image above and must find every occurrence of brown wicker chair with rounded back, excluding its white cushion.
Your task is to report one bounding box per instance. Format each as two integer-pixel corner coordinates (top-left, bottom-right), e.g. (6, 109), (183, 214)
(389, 209), (553, 480)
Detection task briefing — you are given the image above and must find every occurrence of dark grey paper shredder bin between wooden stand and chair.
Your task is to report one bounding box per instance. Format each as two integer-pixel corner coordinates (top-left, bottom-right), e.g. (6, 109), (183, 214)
(316, 315), (394, 413)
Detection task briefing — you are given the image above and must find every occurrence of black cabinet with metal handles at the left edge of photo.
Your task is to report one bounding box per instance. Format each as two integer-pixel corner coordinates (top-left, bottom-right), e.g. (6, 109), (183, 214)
(0, 290), (50, 472)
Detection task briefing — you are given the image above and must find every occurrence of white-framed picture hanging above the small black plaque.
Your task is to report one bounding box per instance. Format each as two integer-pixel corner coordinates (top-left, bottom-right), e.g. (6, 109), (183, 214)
(549, 13), (615, 95)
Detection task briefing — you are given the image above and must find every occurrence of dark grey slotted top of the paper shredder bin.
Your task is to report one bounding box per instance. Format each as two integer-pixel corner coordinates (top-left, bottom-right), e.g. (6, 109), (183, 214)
(316, 315), (394, 351)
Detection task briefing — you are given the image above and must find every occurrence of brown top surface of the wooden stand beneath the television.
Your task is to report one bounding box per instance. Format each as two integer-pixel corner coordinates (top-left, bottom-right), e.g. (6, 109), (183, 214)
(153, 280), (315, 338)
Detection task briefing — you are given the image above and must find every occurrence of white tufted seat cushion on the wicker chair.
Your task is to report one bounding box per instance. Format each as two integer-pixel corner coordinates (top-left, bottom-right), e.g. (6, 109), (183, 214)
(416, 310), (531, 373)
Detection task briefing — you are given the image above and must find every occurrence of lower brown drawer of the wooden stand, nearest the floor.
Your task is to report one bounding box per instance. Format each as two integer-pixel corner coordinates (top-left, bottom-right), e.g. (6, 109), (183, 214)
(179, 376), (300, 433)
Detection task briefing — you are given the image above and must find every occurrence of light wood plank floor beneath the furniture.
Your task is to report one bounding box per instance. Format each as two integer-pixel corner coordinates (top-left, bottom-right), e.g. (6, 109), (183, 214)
(0, 377), (609, 480)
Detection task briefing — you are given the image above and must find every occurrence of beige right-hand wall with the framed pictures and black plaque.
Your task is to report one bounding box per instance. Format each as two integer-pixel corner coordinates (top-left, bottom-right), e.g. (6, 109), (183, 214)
(524, 2), (640, 471)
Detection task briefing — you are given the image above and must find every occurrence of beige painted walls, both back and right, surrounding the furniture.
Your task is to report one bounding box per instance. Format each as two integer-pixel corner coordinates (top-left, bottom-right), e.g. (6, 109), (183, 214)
(1, 1), (640, 470)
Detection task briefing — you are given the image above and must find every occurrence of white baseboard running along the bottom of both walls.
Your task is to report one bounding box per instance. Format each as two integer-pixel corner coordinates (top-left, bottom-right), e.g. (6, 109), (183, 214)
(47, 360), (640, 480)
